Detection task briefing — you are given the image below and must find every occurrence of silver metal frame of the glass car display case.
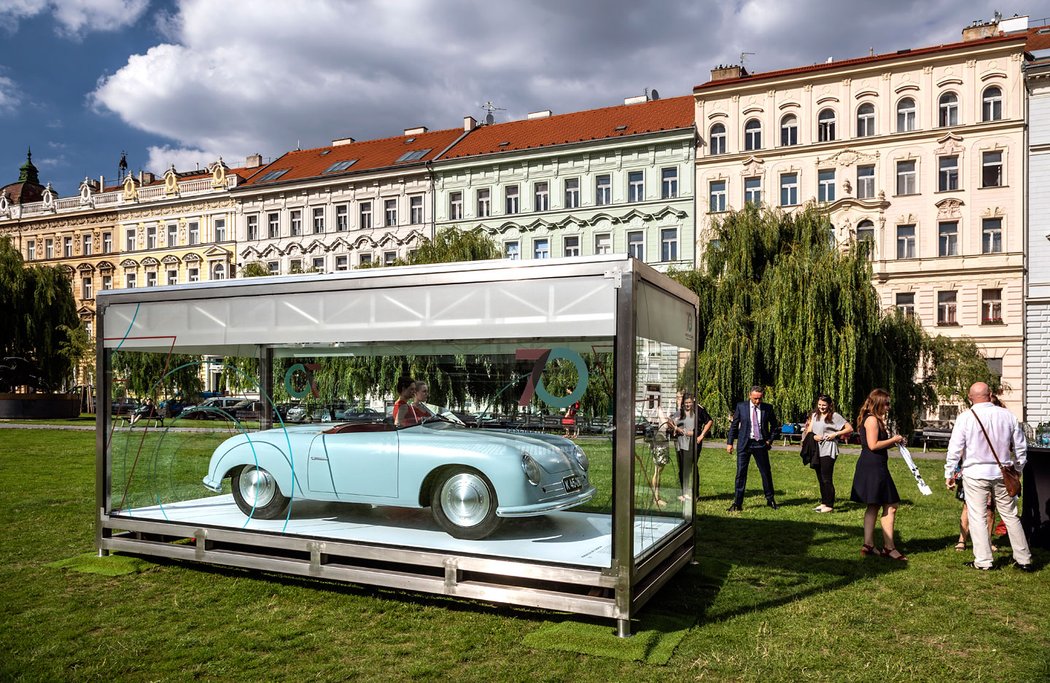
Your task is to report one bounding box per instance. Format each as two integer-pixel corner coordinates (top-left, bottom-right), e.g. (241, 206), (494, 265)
(96, 255), (697, 637)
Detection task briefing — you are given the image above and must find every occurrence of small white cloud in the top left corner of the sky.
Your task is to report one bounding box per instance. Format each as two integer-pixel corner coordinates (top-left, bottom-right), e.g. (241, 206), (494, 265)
(0, 0), (149, 39)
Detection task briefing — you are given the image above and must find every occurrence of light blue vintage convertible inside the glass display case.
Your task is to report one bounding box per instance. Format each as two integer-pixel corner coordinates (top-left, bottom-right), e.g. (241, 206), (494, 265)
(204, 413), (595, 539)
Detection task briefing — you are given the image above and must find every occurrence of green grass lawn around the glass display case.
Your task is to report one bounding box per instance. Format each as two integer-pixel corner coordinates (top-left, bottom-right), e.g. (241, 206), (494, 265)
(0, 430), (1050, 681)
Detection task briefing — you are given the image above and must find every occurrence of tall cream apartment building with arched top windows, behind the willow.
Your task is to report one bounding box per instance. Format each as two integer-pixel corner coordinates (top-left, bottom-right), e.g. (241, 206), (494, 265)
(694, 24), (1026, 418)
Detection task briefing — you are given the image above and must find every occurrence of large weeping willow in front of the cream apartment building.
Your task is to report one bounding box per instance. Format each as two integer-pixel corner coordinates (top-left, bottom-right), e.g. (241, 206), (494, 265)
(672, 206), (923, 427)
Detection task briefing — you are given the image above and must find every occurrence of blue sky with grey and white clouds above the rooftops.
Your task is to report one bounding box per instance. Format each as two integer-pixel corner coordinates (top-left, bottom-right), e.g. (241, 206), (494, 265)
(0, 0), (1050, 195)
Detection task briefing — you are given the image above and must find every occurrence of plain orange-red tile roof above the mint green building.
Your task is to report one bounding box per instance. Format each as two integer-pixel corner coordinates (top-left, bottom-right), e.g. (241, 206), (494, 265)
(441, 96), (694, 160)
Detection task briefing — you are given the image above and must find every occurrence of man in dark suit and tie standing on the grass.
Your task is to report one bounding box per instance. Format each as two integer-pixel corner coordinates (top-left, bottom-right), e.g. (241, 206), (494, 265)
(726, 386), (780, 512)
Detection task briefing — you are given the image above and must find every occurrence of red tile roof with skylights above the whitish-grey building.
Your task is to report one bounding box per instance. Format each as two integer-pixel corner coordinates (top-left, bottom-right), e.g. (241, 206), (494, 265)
(245, 128), (463, 186)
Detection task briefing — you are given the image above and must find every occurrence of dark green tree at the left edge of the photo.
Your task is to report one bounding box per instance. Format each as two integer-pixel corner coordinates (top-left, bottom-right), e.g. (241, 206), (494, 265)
(0, 236), (80, 389)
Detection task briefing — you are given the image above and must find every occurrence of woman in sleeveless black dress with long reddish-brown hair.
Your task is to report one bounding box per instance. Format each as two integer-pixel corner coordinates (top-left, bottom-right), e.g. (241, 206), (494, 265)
(849, 389), (908, 561)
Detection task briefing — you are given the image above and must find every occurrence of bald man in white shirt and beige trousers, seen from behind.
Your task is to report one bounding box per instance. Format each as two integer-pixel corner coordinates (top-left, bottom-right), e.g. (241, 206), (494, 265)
(944, 381), (1032, 572)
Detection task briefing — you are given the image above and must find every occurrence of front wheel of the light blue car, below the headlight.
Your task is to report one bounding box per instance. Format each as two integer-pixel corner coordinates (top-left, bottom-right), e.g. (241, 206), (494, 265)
(431, 467), (503, 540)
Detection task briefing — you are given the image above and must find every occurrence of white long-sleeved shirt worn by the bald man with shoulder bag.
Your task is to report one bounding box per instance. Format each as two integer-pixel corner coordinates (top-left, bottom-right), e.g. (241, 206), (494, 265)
(944, 402), (1028, 479)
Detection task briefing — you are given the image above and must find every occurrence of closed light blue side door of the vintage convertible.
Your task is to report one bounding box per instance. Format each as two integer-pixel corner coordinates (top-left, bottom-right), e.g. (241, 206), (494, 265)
(309, 425), (398, 493)
